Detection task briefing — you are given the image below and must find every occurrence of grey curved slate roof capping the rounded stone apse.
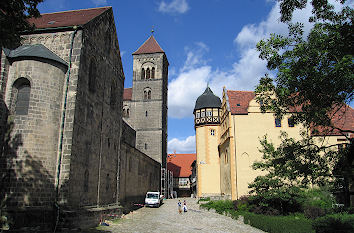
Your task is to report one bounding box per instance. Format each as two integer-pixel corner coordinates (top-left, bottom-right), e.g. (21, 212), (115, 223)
(4, 44), (68, 66)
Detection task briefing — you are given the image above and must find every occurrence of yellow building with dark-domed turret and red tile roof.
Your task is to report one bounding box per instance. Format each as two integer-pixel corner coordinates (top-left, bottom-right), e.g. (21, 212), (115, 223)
(194, 87), (354, 200)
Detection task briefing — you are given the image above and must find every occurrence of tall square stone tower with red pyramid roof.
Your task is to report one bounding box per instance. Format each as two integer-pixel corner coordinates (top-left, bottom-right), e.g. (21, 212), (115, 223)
(130, 35), (169, 167)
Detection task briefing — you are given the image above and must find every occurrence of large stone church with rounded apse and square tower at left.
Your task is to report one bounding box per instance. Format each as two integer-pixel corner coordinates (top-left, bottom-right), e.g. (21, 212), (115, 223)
(0, 7), (168, 230)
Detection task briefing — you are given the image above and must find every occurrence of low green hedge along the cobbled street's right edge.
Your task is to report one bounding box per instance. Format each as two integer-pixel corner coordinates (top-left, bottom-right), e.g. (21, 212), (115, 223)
(244, 212), (314, 233)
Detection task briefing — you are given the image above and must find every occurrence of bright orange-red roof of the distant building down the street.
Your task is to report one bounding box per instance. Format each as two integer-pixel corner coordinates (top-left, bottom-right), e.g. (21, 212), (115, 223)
(167, 154), (197, 177)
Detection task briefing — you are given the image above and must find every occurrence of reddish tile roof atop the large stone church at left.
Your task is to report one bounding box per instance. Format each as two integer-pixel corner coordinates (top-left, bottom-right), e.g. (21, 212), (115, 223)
(28, 7), (111, 28)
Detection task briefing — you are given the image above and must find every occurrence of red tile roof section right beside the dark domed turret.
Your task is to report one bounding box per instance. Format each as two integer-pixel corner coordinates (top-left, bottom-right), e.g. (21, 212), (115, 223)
(227, 90), (256, 114)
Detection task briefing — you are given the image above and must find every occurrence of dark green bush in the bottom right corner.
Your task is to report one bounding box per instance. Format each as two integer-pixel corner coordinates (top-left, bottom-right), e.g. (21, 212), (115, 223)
(312, 214), (354, 233)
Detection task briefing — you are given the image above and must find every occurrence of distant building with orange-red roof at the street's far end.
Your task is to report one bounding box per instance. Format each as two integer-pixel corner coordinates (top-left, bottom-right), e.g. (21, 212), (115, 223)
(167, 154), (196, 197)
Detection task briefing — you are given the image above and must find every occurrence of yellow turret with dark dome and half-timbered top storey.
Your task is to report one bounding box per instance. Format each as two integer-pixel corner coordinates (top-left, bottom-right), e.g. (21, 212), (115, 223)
(193, 86), (221, 197)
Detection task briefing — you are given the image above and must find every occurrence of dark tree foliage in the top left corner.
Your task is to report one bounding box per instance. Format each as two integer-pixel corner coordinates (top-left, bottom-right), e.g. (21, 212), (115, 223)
(0, 0), (43, 49)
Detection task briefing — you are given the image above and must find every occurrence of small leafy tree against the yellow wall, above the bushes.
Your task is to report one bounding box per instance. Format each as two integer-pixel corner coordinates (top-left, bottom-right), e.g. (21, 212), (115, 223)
(251, 132), (340, 189)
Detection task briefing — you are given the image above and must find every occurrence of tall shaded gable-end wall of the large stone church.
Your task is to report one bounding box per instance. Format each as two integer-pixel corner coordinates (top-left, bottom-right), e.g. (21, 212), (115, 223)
(63, 7), (124, 207)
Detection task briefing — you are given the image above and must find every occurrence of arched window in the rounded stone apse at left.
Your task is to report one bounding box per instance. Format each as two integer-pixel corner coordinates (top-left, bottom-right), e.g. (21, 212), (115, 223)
(12, 78), (31, 115)
